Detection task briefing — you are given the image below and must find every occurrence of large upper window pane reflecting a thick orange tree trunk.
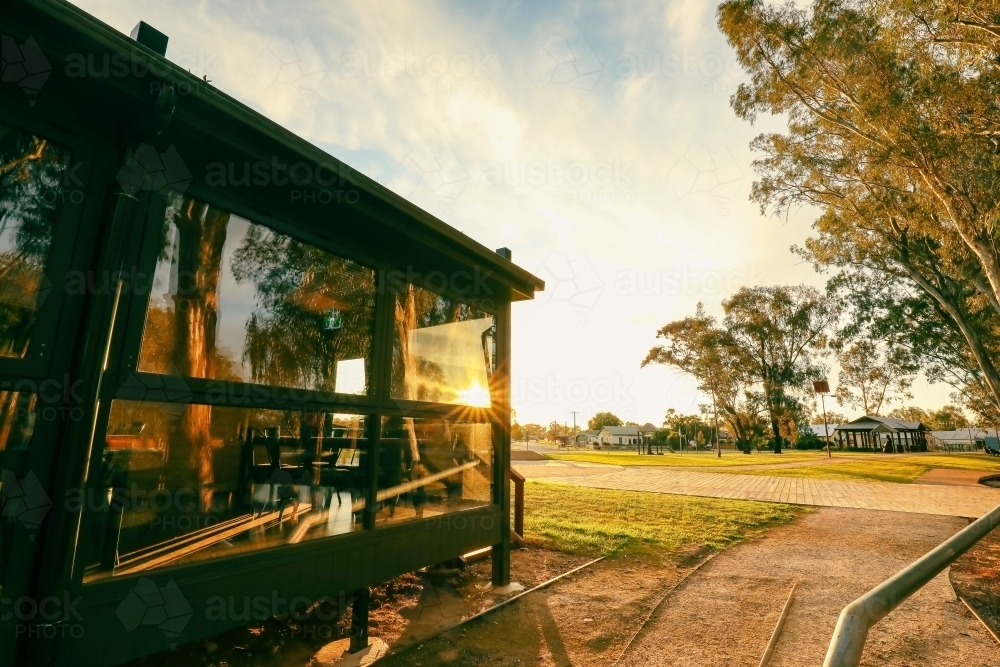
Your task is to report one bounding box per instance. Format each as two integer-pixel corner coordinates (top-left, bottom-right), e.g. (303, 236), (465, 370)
(139, 195), (375, 394)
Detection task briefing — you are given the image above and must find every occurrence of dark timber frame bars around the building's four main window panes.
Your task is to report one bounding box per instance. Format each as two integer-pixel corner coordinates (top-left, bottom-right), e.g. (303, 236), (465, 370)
(72, 176), (510, 589)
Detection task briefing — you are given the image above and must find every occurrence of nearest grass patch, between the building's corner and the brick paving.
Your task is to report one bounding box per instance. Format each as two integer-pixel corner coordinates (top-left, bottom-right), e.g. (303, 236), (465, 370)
(524, 481), (811, 558)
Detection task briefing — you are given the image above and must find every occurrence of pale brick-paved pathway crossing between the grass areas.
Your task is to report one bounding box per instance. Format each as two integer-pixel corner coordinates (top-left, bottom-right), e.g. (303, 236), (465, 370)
(515, 463), (1000, 517)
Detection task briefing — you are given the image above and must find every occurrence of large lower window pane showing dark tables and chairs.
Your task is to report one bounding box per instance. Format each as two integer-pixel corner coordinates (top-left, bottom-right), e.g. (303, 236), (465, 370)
(80, 401), (368, 581)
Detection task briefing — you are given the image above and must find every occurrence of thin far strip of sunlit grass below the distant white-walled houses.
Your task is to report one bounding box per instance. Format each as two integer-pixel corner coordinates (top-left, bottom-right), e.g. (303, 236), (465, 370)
(546, 450), (852, 468)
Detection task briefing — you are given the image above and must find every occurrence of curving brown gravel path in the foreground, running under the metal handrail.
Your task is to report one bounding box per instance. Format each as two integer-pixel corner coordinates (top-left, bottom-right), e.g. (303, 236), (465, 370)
(620, 508), (1000, 667)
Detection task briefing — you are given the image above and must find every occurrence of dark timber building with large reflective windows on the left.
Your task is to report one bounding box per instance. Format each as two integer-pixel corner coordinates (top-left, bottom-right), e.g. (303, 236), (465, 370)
(0, 0), (544, 667)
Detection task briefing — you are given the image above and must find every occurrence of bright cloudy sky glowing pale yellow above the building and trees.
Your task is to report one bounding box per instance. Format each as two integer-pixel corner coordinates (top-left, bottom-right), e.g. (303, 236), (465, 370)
(75, 0), (950, 425)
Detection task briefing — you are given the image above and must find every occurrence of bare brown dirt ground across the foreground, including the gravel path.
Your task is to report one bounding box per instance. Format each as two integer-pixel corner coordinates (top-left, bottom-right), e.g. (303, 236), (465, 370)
(125, 508), (1000, 667)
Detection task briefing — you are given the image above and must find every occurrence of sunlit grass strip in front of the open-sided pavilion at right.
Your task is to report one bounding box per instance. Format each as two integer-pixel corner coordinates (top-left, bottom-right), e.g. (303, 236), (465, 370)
(719, 454), (1000, 484)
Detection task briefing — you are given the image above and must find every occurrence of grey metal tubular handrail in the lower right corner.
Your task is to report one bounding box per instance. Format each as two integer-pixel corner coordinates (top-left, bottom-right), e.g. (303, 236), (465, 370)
(823, 505), (1000, 667)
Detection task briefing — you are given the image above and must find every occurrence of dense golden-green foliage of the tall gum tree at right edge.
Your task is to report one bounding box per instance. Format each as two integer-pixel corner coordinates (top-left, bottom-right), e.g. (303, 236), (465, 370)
(719, 0), (1000, 420)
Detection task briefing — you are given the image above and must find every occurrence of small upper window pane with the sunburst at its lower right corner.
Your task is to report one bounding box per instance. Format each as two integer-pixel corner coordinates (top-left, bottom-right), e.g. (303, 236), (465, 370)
(392, 285), (496, 408)
